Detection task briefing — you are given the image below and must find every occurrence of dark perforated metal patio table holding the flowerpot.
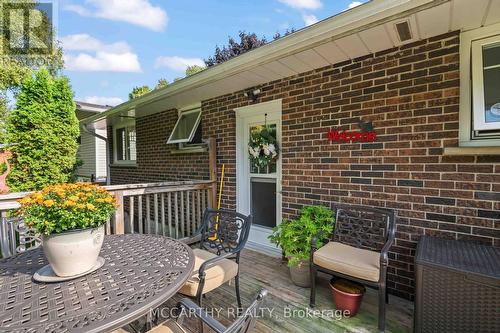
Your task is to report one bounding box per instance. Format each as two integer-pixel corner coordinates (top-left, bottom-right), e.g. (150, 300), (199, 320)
(0, 234), (194, 333)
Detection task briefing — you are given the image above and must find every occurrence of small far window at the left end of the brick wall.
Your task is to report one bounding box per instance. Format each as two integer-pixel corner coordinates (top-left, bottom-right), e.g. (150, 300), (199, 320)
(113, 121), (137, 165)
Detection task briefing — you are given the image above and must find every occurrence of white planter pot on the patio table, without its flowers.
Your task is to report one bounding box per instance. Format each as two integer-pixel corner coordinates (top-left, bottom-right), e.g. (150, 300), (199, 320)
(42, 225), (104, 277)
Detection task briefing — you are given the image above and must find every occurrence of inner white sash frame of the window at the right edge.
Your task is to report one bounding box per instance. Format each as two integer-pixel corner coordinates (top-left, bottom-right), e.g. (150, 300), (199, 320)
(471, 31), (500, 131)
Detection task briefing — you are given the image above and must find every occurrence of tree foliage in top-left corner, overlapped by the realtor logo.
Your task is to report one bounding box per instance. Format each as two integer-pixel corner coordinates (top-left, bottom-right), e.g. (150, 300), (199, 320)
(0, 0), (63, 143)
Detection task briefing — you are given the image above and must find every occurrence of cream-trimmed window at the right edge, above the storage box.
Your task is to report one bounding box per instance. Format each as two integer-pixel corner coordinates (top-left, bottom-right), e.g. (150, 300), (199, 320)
(459, 24), (500, 147)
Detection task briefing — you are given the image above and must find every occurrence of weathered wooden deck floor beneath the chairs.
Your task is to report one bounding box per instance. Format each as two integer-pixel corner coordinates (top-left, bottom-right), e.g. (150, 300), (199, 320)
(150, 250), (413, 333)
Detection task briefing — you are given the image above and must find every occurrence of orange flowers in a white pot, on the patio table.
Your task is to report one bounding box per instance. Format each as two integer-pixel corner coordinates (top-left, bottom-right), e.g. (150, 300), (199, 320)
(19, 183), (116, 277)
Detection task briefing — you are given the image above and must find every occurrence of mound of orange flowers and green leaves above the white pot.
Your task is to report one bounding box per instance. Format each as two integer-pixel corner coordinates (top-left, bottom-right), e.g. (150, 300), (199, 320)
(18, 183), (116, 235)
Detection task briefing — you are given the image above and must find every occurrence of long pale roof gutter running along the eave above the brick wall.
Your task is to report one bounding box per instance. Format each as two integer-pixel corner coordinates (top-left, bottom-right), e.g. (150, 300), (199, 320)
(81, 0), (450, 124)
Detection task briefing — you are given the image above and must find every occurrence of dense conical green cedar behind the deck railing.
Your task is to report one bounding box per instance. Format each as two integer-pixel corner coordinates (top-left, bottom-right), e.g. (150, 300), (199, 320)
(7, 69), (80, 192)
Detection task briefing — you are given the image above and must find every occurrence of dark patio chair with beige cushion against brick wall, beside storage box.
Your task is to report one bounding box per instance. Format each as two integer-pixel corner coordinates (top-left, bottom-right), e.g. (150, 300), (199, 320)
(310, 205), (396, 332)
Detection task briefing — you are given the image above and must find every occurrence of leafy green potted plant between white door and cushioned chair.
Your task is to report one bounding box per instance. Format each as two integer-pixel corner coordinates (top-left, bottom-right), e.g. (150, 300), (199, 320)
(269, 206), (335, 287)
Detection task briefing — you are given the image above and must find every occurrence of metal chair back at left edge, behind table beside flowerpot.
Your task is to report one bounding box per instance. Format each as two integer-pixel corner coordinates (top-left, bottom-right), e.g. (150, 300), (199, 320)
(0, 216), (42, 258)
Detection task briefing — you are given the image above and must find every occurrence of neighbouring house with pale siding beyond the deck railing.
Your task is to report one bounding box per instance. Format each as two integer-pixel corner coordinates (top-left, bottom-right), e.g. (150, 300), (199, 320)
(75, 101), (110, 183)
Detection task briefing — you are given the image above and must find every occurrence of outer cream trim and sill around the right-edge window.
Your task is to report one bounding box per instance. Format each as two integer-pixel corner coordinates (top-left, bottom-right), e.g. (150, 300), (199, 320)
(458, 23), (500, 147)
